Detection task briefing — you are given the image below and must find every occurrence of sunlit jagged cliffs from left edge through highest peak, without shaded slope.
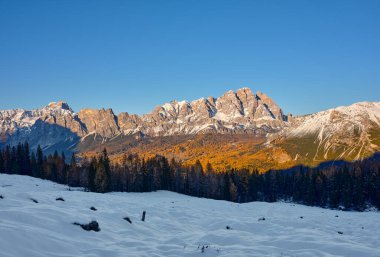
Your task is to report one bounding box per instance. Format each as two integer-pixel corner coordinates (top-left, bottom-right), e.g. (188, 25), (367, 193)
(0, 88), (287, 144)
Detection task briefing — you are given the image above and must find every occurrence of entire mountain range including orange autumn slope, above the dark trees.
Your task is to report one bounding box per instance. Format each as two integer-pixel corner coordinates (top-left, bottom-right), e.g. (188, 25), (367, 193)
(0, 88), (380, 171)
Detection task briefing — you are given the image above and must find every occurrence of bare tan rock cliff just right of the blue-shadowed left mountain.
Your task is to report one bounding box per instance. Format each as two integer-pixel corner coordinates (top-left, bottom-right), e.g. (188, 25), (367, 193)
(78, 109), (120, 138)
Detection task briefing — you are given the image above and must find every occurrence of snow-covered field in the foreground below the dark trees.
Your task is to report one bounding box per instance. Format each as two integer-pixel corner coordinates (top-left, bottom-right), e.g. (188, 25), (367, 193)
(0, 175), (380, 257)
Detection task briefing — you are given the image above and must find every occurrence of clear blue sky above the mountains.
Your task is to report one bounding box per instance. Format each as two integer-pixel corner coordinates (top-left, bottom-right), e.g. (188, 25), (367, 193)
(0, 0), (380, 114)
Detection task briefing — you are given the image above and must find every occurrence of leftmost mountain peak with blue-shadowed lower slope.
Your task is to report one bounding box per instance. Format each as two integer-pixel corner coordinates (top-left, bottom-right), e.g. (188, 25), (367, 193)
(0, 102), (87, 153)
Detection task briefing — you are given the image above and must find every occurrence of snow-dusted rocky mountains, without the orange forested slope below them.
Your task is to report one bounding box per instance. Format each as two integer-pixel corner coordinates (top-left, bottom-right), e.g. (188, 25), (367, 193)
(0, 87), (380, 165)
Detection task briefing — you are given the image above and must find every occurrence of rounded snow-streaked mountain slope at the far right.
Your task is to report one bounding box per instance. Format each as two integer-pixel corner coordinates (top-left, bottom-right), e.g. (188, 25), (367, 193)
(284, 102), (380, 161)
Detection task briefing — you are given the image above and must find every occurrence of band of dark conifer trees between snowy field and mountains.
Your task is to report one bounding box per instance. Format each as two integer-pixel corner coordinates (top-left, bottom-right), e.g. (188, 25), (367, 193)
(0, 142), (380, 210)
